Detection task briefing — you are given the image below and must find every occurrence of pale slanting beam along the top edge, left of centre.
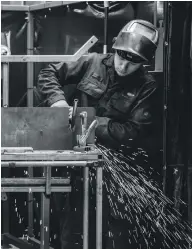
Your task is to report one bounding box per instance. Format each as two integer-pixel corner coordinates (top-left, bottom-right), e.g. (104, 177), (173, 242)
(29, 1), (82, 11)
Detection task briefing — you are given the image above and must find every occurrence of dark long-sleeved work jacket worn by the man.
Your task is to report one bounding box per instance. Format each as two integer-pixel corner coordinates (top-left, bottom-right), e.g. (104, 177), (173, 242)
(37, 53), (160, 148)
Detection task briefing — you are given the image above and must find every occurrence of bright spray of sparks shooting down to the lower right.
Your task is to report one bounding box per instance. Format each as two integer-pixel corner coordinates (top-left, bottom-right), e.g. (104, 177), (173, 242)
(97, 145), (192, 249)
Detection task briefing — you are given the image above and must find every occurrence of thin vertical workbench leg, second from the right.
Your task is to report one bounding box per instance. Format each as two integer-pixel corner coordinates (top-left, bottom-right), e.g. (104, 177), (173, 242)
(83, 167), (89, 249)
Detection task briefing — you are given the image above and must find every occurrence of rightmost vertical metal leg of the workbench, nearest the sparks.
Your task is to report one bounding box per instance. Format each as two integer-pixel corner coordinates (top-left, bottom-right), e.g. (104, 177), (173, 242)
(96, 167), (103, 249)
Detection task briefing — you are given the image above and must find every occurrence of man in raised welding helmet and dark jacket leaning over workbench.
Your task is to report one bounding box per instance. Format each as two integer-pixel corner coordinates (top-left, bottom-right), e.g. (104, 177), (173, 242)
(38, 20), (159, 249)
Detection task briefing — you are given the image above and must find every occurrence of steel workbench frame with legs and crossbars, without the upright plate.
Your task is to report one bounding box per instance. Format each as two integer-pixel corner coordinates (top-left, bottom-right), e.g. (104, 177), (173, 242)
(1, 148), (103, 249)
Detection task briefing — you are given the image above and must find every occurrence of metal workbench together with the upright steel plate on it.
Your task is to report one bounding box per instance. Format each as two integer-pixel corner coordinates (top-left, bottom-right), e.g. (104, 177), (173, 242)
(1, 108), (103, 249)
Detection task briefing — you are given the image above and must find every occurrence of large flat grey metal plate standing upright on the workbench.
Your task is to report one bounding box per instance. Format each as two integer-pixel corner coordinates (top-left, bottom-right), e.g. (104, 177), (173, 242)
(1, 107), (95, 150)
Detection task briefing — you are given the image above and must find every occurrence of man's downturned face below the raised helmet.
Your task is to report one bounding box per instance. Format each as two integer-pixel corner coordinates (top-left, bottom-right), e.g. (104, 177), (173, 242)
(114, 50), (144, 77)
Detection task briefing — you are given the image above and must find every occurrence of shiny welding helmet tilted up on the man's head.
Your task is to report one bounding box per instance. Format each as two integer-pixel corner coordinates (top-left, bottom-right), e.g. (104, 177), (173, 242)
(113, 20), (159, 61)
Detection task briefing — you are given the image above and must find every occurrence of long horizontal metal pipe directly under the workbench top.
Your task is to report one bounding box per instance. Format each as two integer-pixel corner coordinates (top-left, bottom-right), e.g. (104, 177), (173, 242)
(1, 161), (94, 168)
